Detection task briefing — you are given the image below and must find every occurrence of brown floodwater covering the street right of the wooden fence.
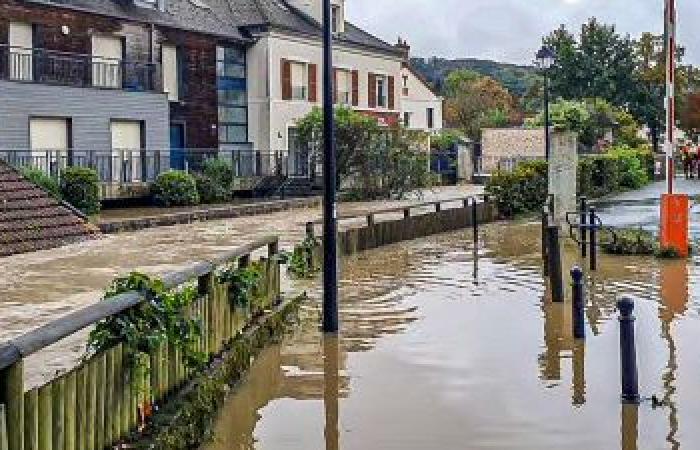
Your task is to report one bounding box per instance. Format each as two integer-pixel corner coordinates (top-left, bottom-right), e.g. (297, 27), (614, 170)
(206, 224), (700, 450)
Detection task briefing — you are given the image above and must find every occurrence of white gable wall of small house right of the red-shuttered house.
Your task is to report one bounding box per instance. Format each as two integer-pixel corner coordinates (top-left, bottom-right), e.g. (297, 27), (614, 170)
(399, 67), (442, 131)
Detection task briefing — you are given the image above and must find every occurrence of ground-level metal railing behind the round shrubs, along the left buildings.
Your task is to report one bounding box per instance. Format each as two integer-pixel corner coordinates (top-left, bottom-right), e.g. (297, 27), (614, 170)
(0, 149), (315, 184)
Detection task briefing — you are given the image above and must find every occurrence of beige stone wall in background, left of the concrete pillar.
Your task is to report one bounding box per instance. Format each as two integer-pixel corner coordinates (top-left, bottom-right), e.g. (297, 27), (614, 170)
(481, 128), (545, 173)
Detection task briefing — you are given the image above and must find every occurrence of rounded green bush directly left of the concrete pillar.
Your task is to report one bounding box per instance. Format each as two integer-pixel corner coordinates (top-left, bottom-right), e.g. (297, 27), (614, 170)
(486, 161), (547, 218)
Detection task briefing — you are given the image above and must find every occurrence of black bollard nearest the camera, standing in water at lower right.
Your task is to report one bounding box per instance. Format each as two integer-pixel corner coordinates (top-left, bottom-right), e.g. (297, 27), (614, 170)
(617, 296), (639, 404)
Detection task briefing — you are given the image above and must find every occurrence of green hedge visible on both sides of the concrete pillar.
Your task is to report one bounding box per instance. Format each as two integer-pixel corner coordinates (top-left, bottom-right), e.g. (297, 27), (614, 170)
(486, 146), (654, 218)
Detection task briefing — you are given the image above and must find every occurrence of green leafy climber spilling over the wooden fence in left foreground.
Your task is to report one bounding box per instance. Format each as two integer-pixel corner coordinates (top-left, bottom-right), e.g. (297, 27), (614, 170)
(88, 272), (206, 367)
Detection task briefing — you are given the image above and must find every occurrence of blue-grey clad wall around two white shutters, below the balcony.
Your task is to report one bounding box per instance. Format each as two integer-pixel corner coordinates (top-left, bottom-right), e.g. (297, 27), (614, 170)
(0, 81), (170, 150)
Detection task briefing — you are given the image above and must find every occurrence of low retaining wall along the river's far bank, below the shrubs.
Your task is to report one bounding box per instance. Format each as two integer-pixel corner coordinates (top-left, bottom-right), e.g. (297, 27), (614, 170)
(98, 197), (321, 234)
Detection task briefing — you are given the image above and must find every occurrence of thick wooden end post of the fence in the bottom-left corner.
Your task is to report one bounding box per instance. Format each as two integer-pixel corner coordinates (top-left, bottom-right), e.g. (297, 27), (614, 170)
(0, 359), (24, 450)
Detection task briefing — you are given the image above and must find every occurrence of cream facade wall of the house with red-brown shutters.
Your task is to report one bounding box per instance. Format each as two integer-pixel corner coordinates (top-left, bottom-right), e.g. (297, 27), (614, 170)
(248, 33), (401, 150)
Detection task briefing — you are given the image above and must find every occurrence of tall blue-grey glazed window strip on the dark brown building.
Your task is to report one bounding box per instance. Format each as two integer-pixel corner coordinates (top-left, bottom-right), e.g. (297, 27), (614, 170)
(216, 47), (248, 144)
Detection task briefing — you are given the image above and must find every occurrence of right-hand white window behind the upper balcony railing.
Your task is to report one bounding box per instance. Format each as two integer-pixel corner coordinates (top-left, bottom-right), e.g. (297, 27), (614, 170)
(92, 35), (124, 89)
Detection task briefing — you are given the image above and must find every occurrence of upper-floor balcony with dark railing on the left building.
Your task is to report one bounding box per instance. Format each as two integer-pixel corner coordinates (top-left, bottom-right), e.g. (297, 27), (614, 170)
(0, 44), (160, 92)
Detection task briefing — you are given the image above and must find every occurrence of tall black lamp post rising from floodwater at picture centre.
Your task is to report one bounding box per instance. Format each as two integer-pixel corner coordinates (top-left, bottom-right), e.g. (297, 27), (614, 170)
(323, 0), (338, 333)
